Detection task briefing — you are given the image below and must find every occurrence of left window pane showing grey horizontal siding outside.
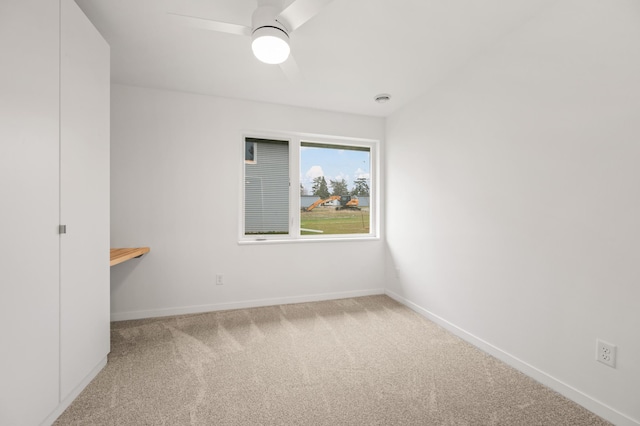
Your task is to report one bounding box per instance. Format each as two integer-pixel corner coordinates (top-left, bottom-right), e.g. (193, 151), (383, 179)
(244, 138), (289, 235)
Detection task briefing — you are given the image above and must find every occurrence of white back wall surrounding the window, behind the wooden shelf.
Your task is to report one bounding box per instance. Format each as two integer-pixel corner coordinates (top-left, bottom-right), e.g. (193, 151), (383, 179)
(111, 85), (384, 320)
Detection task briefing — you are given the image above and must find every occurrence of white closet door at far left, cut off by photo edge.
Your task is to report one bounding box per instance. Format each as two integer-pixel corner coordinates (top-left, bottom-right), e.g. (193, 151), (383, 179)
(0, 0), (59, 425)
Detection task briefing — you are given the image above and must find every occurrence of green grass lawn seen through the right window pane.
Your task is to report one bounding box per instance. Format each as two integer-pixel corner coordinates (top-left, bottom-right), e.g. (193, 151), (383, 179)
(300, 206), (369, 235)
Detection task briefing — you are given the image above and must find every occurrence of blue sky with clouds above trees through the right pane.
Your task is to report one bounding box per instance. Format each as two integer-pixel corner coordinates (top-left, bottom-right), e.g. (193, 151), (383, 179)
(300, 146), (371, 194)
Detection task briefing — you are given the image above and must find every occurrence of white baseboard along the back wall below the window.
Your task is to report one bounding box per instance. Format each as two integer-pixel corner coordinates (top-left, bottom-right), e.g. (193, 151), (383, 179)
(111, 288), (384, 321)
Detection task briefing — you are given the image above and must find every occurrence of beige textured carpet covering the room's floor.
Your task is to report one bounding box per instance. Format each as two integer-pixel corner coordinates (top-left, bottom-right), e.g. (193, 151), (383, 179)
(55, 296), (609, 426)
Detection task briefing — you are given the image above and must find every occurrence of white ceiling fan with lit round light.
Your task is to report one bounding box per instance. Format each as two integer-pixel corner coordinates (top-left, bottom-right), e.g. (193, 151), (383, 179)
(169, 0), (332, 79)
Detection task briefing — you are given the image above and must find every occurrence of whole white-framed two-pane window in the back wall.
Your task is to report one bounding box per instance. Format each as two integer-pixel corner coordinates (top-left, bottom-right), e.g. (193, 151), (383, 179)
(241, 137), (377, 241)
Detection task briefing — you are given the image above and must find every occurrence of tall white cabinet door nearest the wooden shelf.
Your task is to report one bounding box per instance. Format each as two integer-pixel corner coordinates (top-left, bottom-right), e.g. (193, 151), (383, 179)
(60, 0), (110, 401)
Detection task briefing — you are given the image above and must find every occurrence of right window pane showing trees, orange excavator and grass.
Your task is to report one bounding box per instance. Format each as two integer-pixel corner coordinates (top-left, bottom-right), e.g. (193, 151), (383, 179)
(300, 142), (371, 235)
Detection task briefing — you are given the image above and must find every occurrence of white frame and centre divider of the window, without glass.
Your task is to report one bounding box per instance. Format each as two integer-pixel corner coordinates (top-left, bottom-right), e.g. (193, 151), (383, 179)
(238, 131), (381, 244)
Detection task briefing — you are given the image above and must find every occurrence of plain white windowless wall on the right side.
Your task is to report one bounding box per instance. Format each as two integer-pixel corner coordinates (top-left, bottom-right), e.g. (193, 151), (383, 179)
(385, 0), (640, 424)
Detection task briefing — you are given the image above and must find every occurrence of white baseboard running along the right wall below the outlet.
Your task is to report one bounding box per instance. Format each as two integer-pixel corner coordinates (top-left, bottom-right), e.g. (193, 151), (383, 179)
(385, 290), (640, 426)
